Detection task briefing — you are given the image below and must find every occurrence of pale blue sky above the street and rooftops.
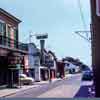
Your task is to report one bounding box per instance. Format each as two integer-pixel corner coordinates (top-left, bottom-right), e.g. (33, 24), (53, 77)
(0, 0), (91, 66)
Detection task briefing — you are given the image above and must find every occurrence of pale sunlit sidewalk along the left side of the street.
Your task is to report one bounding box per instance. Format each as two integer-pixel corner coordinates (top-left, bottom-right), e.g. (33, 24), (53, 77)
(0, 79), (62, 97)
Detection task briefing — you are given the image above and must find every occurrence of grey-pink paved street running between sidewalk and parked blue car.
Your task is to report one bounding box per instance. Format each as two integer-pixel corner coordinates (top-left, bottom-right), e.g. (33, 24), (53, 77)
(5, 74), (81, 98)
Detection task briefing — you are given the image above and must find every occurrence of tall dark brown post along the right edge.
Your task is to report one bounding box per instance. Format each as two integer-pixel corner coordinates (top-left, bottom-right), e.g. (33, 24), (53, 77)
(90, 0), (100, 97)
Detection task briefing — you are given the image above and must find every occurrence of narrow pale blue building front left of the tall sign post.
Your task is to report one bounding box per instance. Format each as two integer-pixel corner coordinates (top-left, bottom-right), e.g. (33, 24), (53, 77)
(28, 43), (41, 81)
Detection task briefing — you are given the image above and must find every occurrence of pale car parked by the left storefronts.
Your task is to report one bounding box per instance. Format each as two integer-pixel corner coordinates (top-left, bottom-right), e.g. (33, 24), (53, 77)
(19, 74), (34, 85)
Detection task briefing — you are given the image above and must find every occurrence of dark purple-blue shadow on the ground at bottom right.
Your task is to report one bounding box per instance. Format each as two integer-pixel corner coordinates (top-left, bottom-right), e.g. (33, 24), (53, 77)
(74, 85), (93, 98)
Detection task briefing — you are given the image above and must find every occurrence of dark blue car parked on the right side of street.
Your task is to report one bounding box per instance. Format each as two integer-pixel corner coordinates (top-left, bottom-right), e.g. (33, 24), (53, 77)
(82, 70), (93, 81)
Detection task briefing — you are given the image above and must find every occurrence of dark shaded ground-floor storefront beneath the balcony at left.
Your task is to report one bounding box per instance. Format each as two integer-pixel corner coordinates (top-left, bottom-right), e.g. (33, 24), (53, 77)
(0, 48), (27, 86)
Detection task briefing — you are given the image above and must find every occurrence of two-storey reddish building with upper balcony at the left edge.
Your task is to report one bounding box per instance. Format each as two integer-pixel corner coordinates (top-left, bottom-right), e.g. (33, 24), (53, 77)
(0, 8), (27, 85)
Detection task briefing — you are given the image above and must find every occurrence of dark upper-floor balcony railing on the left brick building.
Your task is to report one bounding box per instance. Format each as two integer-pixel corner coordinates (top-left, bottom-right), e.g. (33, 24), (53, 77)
(0, 35), (28, 51)
